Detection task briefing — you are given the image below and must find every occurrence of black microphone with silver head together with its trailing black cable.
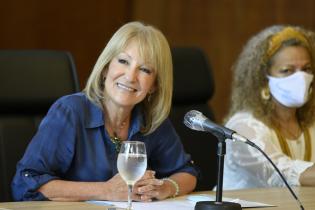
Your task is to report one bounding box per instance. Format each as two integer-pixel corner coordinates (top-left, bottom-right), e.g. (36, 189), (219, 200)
(184, 110), (304, 210)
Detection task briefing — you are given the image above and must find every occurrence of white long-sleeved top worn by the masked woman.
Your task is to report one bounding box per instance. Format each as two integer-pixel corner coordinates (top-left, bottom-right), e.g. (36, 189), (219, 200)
(223, 112), (315, 190)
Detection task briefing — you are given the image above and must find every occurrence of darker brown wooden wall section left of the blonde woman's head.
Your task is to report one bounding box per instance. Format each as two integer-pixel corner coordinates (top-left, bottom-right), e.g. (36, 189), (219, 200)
(0, 0), (131, 88)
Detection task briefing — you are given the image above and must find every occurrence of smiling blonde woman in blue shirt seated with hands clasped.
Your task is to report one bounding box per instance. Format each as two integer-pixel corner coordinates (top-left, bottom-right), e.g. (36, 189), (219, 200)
(12, 22), (197, 201)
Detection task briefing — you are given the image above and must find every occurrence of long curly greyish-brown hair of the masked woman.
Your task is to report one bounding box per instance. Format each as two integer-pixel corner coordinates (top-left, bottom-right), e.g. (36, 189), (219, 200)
(226, 25), (315, 127)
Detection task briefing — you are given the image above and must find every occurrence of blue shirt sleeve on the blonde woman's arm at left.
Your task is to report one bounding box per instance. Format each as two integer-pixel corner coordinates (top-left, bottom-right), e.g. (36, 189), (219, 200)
(11, 101), (77, 201)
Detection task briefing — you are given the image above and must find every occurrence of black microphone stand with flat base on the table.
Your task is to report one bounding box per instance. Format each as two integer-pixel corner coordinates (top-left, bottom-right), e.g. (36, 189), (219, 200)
(195, 132), (242, 210)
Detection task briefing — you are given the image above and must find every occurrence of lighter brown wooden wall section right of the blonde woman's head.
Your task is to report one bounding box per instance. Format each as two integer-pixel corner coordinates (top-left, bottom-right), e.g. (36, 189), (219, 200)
(132, 0), (315, 121)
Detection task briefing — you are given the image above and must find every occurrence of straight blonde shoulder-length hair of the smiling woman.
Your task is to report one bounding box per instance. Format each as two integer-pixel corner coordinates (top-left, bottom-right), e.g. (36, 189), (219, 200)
(84, 22), (173, 134)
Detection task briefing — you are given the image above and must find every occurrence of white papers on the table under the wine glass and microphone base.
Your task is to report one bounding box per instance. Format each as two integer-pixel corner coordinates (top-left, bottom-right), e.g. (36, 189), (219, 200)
(88, 194), (274, 210)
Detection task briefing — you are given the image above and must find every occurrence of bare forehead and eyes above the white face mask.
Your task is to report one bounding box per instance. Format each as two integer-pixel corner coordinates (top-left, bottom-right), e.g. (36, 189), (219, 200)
(269, 46), (313, 77)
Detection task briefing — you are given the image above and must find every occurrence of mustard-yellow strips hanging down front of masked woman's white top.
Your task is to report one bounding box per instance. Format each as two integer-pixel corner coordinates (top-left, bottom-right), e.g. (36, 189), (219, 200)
(274, 126), (312, 161)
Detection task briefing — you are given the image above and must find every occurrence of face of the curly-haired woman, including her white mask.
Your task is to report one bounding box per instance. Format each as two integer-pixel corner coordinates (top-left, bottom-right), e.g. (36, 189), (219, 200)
(269, 46), (313, 109)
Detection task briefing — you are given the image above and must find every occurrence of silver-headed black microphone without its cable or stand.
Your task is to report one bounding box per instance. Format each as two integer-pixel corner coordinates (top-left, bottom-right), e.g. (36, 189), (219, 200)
(184, 110), (249, 144)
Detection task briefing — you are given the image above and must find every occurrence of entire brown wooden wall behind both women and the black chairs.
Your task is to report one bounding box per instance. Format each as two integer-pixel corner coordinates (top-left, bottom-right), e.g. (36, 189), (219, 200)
(0, 0), (315, 121)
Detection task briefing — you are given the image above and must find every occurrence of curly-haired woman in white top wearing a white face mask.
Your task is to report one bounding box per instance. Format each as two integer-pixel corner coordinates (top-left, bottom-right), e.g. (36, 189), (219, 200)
(224, 26), (315, 189)
